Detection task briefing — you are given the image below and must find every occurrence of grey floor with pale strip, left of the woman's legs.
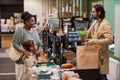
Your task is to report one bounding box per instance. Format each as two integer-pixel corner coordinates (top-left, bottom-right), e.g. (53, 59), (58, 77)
(0, 49), (16, 80)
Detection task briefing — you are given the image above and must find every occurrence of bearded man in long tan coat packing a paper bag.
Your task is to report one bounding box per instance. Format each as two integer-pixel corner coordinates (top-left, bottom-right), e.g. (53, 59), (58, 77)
(85, 4), (113, 80)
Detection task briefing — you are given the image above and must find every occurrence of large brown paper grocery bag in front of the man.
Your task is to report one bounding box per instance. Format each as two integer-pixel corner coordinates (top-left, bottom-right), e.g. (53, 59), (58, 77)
(76, 45), (99, 69)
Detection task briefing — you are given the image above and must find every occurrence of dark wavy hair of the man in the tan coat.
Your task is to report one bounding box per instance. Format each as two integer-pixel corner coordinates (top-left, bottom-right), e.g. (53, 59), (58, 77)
(93, 4), (105, 19)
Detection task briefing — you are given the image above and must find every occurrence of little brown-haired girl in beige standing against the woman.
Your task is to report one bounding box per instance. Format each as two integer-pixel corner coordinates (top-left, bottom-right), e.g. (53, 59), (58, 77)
(22, 40), (37, 80)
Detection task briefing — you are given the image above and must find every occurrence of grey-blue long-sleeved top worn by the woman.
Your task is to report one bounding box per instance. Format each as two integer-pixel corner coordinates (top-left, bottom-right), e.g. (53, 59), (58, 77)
(13, 28), (42, 50)
